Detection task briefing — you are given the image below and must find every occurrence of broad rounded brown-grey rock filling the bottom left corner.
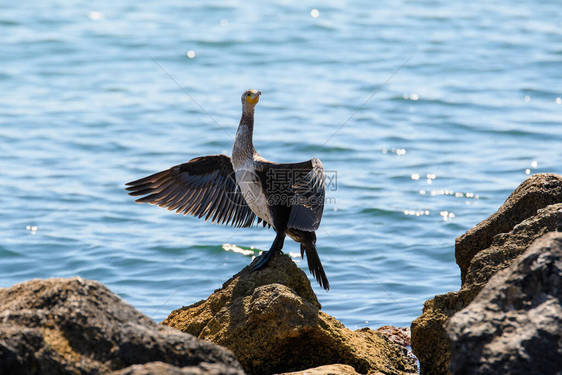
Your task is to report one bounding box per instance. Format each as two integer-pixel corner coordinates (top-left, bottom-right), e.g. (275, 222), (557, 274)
(0, 277), (244, 375)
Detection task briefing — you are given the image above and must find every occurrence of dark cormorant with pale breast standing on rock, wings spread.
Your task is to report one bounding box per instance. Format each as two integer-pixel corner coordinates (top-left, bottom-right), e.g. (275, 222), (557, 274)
(127, 90), (330, 290)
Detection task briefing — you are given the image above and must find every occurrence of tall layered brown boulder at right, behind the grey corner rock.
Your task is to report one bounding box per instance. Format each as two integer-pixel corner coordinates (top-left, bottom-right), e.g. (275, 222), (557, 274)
(411, 174), (562, 375)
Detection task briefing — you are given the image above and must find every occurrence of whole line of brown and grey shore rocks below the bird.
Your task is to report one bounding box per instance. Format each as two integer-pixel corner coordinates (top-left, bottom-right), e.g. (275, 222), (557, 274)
(0, 174), (562, 375)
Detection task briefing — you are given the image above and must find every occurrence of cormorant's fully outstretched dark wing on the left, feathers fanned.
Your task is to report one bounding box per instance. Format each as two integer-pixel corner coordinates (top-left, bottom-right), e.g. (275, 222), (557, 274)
(127, 155), (256, 227)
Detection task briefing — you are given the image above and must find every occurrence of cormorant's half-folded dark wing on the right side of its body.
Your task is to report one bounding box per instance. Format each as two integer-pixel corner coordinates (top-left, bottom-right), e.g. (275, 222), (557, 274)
(267, 158), (326, 231)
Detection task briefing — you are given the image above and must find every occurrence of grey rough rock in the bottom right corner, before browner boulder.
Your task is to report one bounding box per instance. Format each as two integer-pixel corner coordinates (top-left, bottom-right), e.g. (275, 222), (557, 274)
(447, 232), (562, 375)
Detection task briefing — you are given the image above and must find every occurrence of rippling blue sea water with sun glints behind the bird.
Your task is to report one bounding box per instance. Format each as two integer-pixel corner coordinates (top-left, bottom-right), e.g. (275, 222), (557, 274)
(0, 0), (562, 328)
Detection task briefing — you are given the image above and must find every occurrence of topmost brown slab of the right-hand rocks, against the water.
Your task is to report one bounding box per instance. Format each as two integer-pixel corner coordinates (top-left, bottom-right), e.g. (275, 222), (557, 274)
(455, 173), (562, 283)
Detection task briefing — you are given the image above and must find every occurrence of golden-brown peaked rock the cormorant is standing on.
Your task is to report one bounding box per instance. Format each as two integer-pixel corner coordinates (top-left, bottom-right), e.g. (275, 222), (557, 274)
(163, 254), (416, 374)
